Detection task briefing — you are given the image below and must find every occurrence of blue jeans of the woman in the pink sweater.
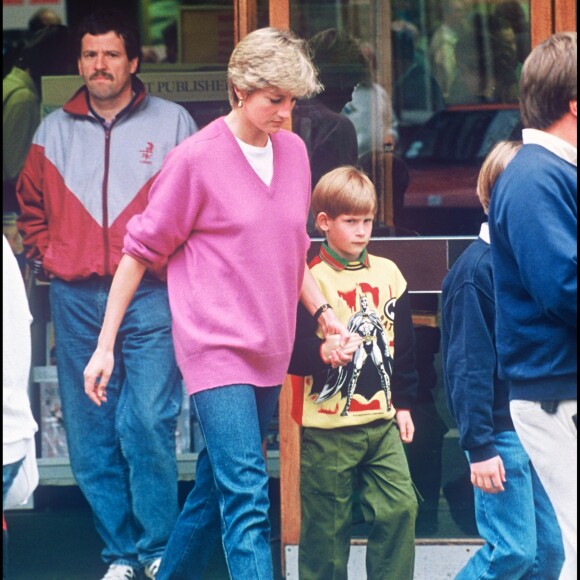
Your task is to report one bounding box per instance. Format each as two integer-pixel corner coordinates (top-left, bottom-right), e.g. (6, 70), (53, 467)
(157, 385), (280, 580)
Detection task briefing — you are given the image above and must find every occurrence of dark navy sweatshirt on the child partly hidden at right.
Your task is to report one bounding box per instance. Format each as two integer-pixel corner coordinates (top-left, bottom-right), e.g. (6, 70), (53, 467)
(441, 231), (514, 462)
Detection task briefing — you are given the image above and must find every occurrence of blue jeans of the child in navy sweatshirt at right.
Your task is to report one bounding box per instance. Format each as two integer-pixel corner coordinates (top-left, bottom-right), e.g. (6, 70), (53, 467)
(456, 431), (572, 580)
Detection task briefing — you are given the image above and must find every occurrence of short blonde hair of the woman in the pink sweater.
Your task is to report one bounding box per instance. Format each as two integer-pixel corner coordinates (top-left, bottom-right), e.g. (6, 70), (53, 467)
(228, 27), (323, 107)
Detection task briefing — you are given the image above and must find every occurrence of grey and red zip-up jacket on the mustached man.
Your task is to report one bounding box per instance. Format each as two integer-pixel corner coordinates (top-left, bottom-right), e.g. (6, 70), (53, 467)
(17, 78), (197, 281)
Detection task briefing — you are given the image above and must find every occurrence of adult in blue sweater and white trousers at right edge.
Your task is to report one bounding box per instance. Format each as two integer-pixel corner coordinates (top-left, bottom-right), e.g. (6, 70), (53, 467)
(489, 32), (578, 579)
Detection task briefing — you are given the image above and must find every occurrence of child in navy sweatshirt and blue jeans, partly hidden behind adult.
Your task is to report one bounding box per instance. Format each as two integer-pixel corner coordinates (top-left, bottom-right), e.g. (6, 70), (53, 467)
(442, 141), (564, 580)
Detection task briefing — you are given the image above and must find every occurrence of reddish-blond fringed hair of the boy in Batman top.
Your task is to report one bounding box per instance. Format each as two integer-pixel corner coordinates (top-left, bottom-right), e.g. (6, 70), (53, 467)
(310, 165), (377, 231)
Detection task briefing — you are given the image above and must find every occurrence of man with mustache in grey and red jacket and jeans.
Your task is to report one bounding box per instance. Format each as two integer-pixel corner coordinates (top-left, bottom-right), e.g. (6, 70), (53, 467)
(17, 11), (197, 580)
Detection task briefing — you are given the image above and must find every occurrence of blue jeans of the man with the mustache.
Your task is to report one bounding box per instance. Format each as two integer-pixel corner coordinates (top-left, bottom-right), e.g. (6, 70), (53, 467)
(50, 278), (182, 568)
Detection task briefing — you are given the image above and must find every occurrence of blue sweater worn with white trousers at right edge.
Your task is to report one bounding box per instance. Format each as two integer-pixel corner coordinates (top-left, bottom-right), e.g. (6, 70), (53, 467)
(489, 144), (578, 401)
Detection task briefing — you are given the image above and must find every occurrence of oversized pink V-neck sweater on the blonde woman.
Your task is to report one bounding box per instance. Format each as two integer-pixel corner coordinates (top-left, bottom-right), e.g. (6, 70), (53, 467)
(123, 118), (310, 394)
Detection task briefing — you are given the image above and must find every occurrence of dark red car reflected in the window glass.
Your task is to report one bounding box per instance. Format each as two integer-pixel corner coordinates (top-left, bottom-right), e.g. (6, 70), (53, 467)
(401, 105), (522, 235)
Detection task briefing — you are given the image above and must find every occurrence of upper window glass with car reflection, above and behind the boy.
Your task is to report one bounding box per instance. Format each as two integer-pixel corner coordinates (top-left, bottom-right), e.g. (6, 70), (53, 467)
(290, 0), (530, 236)
